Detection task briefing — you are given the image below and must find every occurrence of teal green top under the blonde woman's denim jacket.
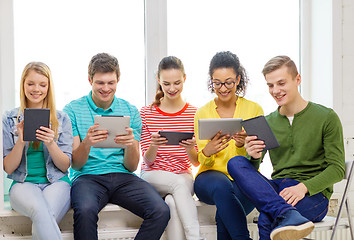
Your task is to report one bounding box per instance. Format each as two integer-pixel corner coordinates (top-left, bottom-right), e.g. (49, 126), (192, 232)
(10, 142), (71, 189)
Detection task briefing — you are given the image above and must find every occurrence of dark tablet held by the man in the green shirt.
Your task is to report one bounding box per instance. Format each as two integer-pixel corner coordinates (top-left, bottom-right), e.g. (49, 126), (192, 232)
(242, 116), (279, 151)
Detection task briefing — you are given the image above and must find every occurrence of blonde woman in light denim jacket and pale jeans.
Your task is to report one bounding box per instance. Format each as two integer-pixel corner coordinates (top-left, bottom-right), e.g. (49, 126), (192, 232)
(2, 62), (73, 240)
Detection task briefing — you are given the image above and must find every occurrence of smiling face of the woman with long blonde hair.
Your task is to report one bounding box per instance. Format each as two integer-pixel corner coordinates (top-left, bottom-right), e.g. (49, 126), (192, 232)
(23, 70), (49, 108)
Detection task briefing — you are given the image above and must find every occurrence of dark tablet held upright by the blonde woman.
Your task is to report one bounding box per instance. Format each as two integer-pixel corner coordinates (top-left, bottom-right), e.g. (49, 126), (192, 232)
(23, 108), (50, 141)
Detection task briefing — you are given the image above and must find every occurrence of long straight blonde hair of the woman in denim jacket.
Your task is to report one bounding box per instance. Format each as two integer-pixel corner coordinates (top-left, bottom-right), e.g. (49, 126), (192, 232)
(17, 62), (59, 149)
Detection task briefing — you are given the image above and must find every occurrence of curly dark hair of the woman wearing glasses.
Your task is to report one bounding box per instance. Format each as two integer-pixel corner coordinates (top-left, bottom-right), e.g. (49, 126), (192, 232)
(208, 51), (249, 96)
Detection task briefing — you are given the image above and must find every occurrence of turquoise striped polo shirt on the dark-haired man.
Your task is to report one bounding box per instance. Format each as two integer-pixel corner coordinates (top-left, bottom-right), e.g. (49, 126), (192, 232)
(64, 92), (141, 181)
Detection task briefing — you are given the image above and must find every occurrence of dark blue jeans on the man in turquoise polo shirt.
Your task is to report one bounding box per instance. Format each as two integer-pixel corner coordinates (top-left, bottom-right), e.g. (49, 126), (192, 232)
(71, 173), (170, 240)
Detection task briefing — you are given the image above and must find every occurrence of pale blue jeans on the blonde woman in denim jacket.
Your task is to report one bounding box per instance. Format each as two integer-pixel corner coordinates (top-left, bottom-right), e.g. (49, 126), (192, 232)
(9, 181), (70, 240)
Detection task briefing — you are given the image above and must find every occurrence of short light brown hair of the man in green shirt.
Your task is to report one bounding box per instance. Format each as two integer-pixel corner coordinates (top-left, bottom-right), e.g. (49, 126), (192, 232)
(262, 55), (299, 78)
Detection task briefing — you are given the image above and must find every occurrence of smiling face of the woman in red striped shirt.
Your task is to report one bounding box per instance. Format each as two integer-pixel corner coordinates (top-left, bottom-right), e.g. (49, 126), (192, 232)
(157, 68), (186, 100)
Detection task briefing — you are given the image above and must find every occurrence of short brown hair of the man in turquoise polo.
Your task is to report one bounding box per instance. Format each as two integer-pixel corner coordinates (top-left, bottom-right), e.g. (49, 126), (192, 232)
(88, 53), (120, 80)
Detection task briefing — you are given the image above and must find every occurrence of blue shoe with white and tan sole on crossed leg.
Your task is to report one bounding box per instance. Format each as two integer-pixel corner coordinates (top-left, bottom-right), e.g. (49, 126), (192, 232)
(270, 209), (315, 240)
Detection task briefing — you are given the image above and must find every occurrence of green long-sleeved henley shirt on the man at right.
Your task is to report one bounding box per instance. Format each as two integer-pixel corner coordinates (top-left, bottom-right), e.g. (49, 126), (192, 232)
(254, 102), (345, 199)
